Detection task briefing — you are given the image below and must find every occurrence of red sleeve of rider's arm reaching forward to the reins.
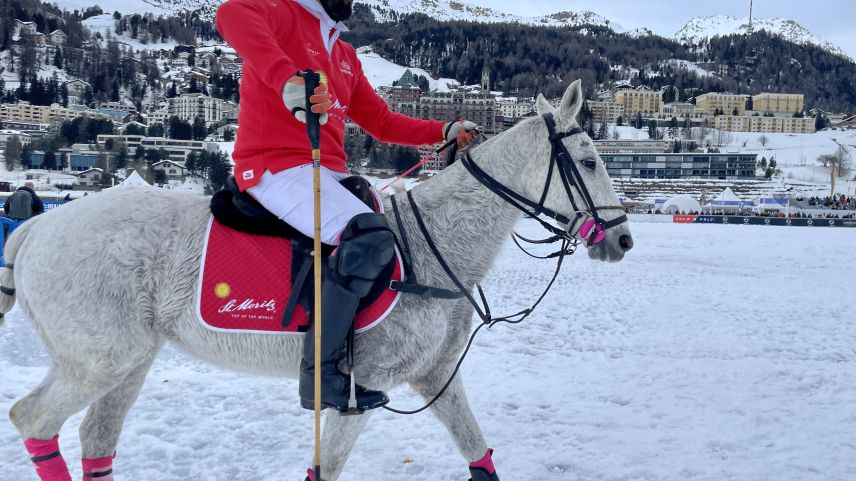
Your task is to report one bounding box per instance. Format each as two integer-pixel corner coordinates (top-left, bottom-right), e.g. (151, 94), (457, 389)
(348, 54), (443, 145)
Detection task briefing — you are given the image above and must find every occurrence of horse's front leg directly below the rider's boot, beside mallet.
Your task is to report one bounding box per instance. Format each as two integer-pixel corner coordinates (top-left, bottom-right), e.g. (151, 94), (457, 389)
(310, 409), (372, 481)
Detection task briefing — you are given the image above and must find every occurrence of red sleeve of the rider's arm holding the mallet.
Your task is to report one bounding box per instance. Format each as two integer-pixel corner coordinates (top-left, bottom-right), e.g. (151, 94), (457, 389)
(215, 0), (297, 92)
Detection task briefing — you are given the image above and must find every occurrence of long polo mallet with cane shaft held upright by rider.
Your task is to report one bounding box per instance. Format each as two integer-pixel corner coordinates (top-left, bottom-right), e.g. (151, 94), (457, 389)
(298, 69), (328, 481)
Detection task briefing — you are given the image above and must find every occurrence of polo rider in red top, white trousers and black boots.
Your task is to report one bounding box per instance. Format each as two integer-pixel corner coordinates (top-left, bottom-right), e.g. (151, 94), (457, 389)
(216, 0), (477, 411)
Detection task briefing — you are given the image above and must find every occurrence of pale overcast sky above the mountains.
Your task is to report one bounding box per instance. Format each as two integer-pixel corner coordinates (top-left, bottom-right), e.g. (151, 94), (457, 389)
(488, 0), (856, 58)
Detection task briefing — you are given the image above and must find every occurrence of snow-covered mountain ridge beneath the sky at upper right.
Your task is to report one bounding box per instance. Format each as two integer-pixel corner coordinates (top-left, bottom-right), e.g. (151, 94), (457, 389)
(674, 15), (850, 58)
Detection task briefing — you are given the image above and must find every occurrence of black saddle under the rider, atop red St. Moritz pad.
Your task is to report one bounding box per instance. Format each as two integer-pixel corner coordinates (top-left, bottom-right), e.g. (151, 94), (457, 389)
(210, 176), (396, 330)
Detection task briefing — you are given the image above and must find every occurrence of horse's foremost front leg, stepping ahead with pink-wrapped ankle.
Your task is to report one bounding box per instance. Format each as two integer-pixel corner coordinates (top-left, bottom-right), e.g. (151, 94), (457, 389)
(411, 366), (499, 481)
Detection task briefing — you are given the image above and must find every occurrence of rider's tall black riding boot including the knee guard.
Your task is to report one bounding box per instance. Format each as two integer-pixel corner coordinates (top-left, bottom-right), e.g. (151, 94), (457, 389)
(300, 214), (395, 412)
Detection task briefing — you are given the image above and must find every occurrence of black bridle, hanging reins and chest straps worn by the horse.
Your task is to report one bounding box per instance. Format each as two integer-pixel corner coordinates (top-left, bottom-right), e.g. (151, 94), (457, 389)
(384, 113), (627, 414)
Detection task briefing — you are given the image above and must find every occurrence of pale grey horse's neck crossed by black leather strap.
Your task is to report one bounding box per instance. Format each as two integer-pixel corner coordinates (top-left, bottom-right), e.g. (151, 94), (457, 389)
(400, 122), (527, 285)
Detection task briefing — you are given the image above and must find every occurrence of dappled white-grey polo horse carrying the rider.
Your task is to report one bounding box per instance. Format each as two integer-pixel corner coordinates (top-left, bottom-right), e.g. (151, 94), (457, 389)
(0, 81), (632, 481)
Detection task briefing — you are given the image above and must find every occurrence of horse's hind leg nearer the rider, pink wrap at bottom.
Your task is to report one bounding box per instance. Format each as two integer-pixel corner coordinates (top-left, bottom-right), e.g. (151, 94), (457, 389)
(80, 356), (154, 481)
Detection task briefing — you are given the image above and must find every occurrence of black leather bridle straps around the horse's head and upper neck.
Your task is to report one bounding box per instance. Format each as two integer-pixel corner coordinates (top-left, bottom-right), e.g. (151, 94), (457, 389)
(461, 113), (627, 245)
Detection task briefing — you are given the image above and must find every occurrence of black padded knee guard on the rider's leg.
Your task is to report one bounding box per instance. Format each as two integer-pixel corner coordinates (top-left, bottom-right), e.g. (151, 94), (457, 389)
(330, 213), (395, 296)
